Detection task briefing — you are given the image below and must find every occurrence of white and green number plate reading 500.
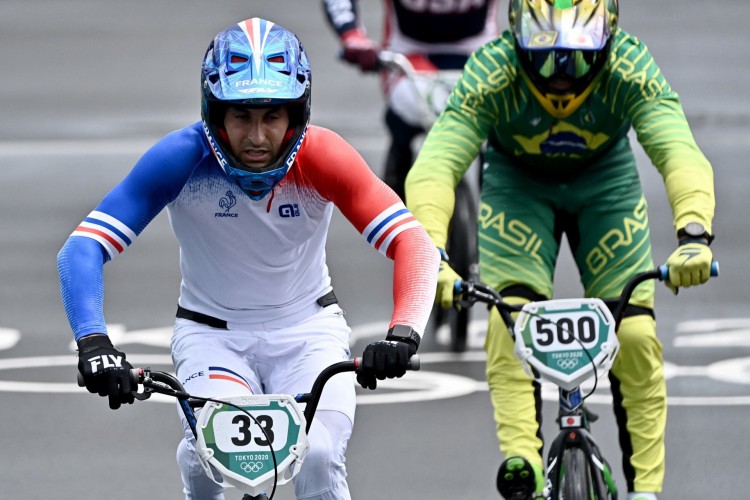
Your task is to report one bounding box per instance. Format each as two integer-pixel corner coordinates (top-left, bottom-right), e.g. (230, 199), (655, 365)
(515, 299), (619, 389)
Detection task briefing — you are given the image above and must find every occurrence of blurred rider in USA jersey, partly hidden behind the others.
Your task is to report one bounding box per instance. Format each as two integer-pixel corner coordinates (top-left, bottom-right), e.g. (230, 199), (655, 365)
(323, 0), (499, 199)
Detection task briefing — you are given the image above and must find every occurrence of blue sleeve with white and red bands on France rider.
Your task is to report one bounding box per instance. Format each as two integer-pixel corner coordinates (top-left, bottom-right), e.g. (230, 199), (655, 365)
(57, 124), (209, 340)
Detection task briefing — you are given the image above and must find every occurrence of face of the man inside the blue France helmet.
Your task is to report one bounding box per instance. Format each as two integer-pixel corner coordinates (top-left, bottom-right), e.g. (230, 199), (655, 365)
(224, 106), (289, 168)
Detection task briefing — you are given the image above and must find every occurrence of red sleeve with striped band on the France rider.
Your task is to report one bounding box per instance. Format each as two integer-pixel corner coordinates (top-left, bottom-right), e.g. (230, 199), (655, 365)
(298, 126), (440, 334)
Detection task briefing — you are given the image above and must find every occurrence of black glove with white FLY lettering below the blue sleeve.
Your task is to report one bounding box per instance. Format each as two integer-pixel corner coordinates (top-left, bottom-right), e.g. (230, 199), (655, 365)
(78, 335), (135, 410)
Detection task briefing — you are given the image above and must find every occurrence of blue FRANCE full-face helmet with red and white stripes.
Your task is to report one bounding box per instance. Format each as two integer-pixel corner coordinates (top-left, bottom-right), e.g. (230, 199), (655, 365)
(201, 17), (311, 200)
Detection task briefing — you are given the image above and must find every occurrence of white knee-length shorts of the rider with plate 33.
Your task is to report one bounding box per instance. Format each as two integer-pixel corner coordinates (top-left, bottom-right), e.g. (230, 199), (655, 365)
(172, 304), (356, 422)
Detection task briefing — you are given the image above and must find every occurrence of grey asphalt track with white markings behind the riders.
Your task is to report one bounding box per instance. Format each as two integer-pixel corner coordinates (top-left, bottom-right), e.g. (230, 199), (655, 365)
(0, 0), (750, 500)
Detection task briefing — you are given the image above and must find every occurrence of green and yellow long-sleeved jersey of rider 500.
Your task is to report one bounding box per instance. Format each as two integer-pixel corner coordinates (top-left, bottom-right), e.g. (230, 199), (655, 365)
(406, 29), (715, 247)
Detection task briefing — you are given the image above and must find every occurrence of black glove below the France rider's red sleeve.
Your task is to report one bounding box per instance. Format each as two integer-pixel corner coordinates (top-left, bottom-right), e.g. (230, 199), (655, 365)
(357, 325), (420, 389)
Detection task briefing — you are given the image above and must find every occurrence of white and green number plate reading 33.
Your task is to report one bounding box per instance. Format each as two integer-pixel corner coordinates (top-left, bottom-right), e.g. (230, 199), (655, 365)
(196, 395), (308, 494)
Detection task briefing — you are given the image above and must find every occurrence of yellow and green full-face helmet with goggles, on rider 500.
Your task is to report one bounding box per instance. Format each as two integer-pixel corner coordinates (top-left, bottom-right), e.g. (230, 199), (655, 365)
(508, 0), (618, 118)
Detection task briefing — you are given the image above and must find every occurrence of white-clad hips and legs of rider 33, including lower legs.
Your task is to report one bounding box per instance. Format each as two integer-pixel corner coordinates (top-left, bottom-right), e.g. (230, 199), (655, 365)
(172, 304), (356, 500)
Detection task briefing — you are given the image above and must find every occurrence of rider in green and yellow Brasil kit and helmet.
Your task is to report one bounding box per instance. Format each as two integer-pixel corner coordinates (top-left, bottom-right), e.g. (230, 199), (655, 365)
(406, 0), (715, 500)
